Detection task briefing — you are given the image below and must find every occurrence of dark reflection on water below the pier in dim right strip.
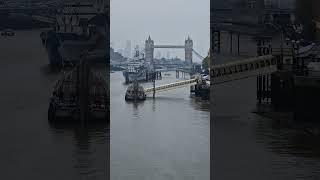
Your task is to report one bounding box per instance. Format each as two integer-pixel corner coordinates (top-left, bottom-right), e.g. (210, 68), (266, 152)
(257, 119), (320, 159)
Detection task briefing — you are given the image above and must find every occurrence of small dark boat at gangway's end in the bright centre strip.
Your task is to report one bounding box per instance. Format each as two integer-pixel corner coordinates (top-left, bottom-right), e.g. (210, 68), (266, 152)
(125, 80), (147, 101)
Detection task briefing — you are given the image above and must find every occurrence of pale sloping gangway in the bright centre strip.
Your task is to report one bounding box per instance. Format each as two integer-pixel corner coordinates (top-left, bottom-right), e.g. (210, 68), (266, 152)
(144, 78), (198, 94)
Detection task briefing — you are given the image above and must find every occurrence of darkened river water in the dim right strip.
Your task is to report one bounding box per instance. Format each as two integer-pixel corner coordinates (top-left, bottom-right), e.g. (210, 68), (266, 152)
(211, 33), (320, 180)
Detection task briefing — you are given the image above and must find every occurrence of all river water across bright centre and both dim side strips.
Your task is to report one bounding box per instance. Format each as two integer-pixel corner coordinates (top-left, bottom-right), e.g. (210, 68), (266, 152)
(0, 31), (320, 180)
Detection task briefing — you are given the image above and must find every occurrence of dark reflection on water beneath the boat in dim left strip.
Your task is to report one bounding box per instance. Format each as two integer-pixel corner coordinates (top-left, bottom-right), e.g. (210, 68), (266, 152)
(50, 123), (110, 179)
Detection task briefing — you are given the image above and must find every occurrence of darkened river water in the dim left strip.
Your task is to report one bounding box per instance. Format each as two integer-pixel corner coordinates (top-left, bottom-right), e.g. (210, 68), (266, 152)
(0, 31), (109, 180)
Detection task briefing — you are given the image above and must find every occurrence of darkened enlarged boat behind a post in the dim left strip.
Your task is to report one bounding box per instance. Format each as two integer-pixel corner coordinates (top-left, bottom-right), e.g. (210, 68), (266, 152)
(48, 64), (109, 122)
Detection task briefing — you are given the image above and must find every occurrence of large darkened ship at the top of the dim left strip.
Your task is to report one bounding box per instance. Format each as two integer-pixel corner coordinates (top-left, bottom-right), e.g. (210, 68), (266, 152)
(40, 0), (108, 66)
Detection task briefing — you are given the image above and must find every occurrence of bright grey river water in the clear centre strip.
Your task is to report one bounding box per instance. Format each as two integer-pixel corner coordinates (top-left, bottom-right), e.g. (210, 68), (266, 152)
(110, 72), (210, 180)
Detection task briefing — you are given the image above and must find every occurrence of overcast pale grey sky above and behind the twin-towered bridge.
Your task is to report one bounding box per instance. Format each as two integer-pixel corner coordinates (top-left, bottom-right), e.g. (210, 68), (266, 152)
(110, 0), (210, 59)
